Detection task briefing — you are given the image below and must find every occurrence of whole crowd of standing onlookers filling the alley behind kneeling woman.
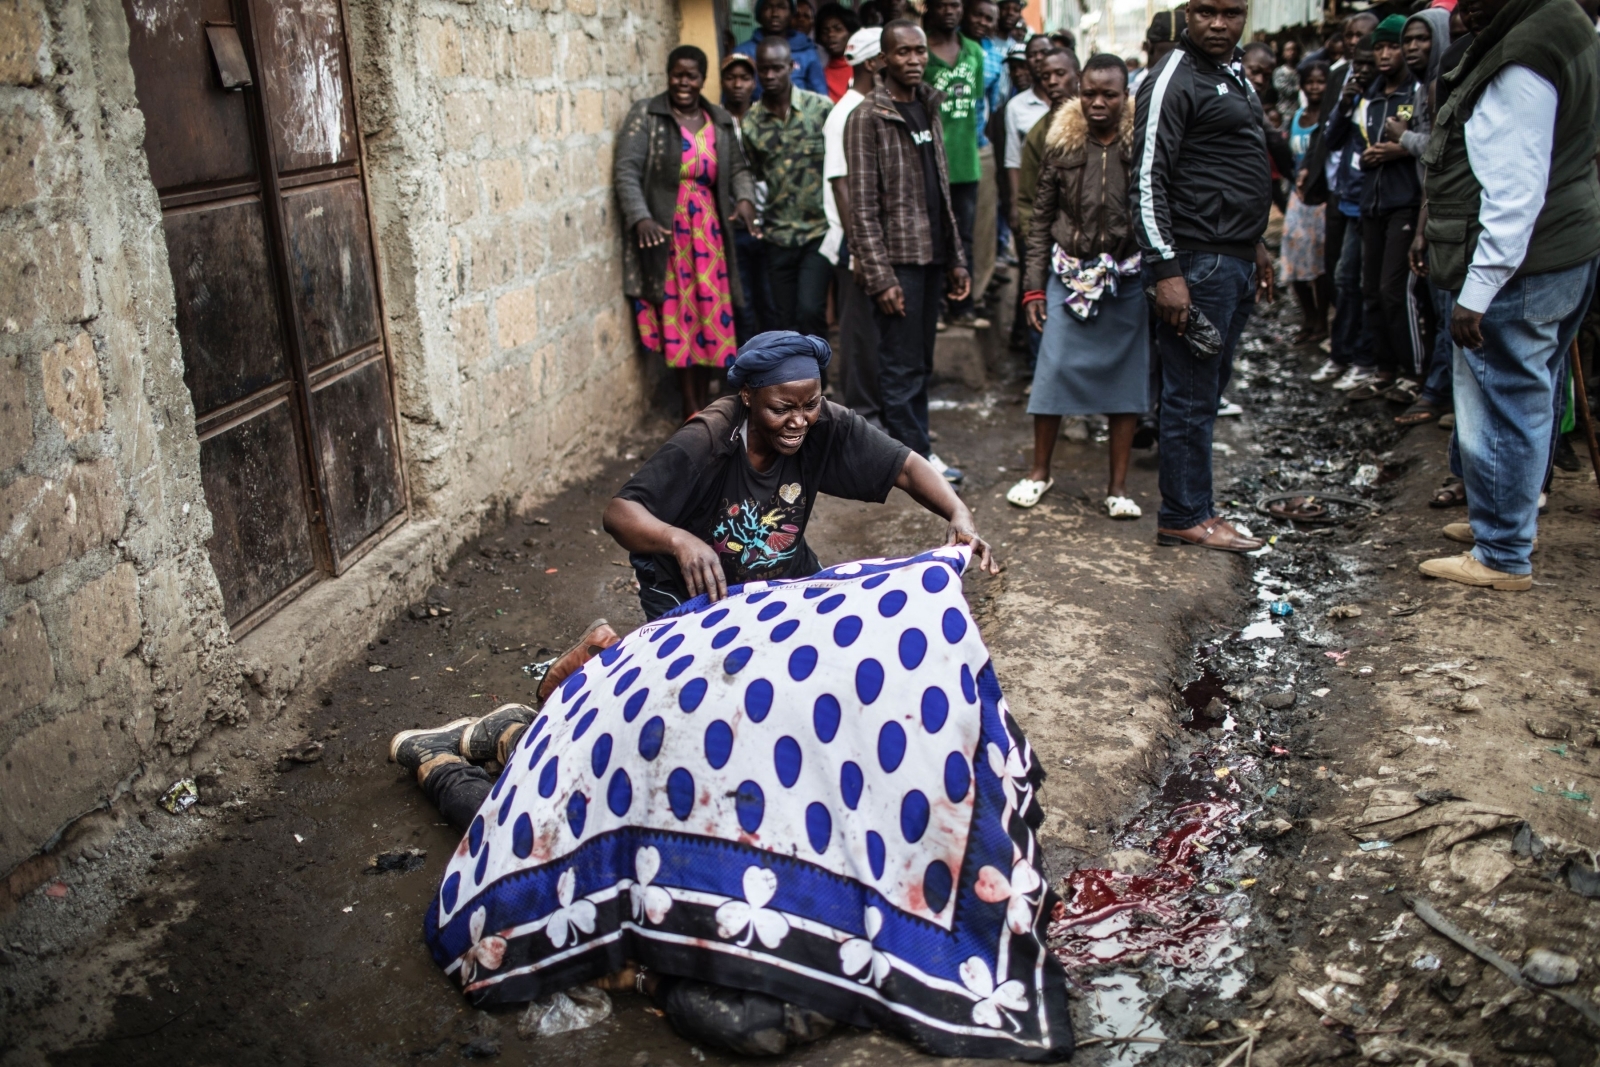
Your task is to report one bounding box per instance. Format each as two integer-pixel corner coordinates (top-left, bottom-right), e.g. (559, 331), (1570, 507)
(616, 0), (1600, 589)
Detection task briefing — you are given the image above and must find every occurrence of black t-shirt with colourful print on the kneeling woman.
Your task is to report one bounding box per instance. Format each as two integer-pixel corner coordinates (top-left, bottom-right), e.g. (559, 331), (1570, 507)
(618, 395), (910, 601)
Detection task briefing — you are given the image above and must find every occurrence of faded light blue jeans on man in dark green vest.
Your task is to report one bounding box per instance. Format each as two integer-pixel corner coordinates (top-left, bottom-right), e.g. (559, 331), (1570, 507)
(1454, 258), (1600, 574)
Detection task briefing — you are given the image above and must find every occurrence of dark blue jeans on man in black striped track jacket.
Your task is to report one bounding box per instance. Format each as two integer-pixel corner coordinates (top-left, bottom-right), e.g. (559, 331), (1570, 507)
(1144, 251), (1256, 530)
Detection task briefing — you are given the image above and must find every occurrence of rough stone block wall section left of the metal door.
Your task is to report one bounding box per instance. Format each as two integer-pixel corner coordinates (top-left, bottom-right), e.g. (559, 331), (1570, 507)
(0, 0), (243, 872)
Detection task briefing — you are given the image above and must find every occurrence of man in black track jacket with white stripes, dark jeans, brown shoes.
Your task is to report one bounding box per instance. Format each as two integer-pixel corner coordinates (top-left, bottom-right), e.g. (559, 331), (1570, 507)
(1128, 0), (1272, 552)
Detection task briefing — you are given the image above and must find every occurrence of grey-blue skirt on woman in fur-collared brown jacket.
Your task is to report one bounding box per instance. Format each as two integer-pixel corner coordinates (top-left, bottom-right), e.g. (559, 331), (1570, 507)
(1027, 274), (1150, 414)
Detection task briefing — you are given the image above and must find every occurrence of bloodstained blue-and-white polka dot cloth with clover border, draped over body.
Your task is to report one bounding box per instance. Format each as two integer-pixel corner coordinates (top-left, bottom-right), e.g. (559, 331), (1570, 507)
(426, 547), (1072, 1059)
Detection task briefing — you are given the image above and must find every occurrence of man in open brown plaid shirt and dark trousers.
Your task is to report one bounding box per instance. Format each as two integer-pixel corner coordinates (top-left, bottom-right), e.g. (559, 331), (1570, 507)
(845, 19), (971, 480)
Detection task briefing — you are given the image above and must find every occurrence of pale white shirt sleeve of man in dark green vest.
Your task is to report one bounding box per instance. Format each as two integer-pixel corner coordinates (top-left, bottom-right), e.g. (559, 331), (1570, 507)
(1456, 64), (1557, 314)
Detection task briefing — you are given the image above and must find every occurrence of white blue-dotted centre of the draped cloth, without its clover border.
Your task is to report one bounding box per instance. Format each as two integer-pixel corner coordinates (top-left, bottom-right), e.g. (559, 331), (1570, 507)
(445, 552), (989, 928)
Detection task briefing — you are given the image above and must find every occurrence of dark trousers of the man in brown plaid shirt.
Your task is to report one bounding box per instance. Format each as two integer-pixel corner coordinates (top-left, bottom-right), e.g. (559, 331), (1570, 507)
(872, 264), (946, 456)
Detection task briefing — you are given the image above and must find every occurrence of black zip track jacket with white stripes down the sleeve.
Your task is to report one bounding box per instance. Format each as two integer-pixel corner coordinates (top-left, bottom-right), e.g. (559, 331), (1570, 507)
(1128, 32), (1272, 278)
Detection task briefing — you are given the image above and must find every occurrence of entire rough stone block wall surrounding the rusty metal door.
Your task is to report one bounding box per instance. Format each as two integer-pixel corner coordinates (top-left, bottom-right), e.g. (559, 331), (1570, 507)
(0, 0), (677, 875)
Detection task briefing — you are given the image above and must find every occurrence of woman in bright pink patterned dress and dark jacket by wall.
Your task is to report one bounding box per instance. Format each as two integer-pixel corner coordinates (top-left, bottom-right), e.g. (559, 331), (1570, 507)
(616, 45), (755, 418)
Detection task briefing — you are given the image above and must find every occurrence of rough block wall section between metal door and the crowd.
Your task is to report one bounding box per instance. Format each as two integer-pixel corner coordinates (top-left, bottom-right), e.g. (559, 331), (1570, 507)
(347, 0), (677, 517)
